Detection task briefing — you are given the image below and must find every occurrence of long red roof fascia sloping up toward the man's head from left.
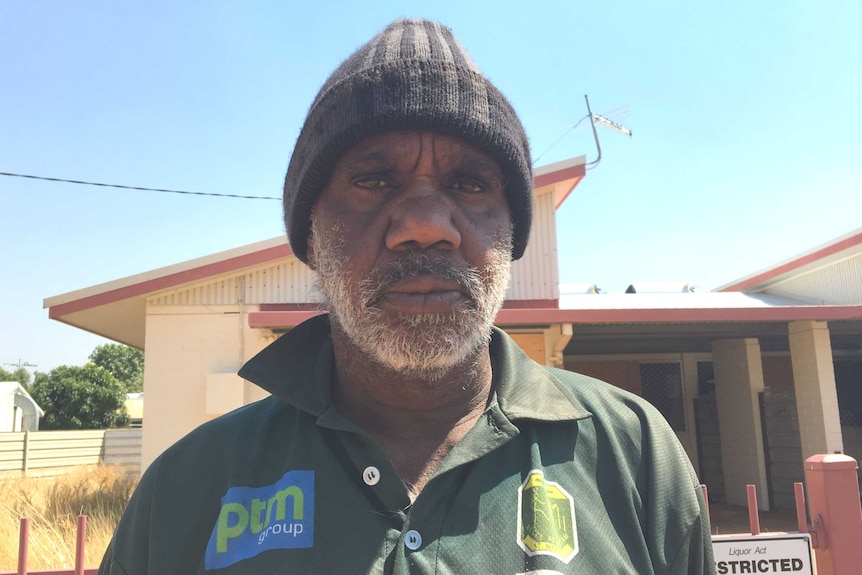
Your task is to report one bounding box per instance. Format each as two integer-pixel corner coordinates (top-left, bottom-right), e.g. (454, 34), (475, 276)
(48, 244), (293, 319)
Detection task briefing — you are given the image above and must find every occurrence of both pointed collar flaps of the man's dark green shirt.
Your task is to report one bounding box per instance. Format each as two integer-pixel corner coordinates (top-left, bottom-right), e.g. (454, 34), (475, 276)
(239, 315), (590, 421)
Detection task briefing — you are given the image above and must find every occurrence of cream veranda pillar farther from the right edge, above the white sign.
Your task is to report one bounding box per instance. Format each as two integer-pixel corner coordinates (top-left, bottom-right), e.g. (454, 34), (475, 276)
(712, 338), (769, 509)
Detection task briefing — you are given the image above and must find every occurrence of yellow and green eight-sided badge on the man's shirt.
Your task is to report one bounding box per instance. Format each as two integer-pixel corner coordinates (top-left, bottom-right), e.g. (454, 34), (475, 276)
(518, 469), (578, 563)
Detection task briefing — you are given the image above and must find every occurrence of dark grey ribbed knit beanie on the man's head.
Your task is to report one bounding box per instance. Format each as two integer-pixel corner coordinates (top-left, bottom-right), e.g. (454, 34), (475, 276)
(284, 16), (533, 262)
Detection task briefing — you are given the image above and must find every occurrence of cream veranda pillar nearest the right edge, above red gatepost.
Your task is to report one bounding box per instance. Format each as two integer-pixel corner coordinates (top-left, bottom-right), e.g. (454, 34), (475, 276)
(788, 321), (844, 459)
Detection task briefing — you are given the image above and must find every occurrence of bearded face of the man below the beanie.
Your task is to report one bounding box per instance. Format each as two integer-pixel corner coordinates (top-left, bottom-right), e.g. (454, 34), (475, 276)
(309, 132), (512, 377)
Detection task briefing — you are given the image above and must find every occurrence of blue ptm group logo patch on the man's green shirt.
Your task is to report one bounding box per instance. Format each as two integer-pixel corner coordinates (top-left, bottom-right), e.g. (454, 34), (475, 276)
(204, 471), (314, 570)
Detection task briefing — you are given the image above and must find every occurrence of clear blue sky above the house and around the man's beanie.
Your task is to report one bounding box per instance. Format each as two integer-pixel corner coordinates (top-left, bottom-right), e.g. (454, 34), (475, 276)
(0, 0), (862, 371)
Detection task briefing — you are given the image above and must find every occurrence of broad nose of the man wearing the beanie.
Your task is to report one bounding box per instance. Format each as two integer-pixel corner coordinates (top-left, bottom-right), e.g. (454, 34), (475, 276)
(386, 181), (461, 251)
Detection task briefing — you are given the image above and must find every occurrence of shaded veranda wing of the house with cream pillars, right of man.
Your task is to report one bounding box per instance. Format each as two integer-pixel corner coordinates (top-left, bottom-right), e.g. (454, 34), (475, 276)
(560, 225), (862, 509)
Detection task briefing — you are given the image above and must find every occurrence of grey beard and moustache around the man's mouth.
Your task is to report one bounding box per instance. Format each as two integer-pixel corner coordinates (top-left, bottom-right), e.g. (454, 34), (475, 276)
(311, 220), (512, 380)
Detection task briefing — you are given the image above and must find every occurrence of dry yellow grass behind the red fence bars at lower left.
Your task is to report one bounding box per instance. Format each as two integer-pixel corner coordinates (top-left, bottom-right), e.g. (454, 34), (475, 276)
(0, 465), (137, 572)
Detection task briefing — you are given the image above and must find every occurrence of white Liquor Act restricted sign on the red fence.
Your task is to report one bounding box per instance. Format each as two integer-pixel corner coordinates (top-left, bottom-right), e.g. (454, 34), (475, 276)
(712, 533), (814, 575)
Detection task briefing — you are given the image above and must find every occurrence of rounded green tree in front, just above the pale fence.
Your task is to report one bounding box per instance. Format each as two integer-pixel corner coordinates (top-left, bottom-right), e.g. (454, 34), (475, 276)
(30, 363), (129, 429)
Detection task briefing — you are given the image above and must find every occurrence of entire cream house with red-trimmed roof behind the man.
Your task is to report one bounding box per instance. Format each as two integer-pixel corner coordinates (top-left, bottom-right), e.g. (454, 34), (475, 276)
(44, 157), (862, 508)
